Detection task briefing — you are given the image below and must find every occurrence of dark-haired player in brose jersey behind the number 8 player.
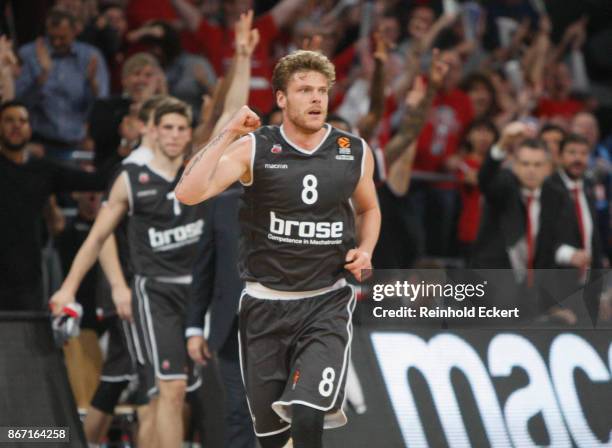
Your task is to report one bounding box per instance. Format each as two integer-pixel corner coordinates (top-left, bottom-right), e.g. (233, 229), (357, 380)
(51, 99), (204, 448)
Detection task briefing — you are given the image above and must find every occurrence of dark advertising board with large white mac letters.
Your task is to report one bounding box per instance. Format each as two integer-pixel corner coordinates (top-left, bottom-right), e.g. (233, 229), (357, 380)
(325, 327), (612, 448)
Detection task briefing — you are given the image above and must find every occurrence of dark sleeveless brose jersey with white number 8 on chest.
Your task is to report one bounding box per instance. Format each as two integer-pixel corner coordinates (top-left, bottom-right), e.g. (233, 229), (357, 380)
(240, 125), (364, 291)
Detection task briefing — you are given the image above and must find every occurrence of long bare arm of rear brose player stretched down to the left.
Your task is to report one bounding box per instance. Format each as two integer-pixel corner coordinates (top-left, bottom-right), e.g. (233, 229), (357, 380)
(50, 175), (128, 315)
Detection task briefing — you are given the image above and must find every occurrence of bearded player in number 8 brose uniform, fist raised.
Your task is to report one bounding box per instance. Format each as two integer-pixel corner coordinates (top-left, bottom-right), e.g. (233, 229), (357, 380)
(176, 50), (380, 448)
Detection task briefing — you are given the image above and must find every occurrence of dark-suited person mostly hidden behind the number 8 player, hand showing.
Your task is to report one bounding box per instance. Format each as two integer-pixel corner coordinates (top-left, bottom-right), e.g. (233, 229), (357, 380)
(186, 187), (255, 448)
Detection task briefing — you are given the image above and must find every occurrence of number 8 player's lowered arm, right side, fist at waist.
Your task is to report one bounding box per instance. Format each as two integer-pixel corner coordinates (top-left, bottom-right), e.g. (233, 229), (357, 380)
(344, 146), (380, 281)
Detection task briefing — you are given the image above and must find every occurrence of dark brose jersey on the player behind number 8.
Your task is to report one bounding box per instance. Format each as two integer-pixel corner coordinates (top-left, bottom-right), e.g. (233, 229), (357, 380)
(123, 164), (204, 277)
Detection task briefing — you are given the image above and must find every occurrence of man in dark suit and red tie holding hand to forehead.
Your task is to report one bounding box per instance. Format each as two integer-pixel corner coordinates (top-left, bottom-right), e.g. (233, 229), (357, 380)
(473, 123), (590, 318)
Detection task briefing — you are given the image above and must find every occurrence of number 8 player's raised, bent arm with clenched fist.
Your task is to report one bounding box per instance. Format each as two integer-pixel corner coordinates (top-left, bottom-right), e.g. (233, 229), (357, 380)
(174, 106), (260, 205)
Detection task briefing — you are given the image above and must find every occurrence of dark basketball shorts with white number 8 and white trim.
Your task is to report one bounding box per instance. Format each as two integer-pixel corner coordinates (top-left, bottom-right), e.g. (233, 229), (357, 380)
(239, 286), (355, 437)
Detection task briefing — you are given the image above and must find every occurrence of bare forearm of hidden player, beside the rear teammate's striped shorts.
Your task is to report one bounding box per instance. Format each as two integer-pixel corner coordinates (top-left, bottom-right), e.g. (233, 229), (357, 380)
(98, 233), (132, 321)
